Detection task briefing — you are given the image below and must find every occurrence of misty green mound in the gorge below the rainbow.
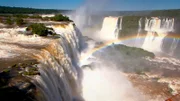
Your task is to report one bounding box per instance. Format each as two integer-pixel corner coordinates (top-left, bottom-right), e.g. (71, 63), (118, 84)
(95, 44), (155, 75)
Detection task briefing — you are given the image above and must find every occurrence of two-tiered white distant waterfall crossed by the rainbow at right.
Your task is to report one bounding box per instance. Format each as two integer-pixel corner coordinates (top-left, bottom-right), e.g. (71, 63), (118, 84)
(142, 17), (176, 52)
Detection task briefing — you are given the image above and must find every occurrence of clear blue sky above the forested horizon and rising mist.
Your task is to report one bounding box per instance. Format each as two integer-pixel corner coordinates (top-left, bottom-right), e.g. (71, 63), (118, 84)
(0, 0), (180, 11)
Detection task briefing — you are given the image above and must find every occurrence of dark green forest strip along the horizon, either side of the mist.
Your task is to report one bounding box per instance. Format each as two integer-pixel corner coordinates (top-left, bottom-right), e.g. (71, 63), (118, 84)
(0, 6), (180, 17)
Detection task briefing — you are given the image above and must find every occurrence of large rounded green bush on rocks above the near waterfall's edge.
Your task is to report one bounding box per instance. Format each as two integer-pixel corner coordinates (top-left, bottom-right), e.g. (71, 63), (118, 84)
(26, 23), (56, 36)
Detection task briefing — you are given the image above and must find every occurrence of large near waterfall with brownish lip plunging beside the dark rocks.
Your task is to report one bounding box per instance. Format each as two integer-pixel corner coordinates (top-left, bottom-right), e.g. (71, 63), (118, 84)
(35, 23), (82, 101)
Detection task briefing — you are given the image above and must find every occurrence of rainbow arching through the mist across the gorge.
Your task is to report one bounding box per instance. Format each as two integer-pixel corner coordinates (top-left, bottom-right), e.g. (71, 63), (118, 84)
(80, 34), (180, 62)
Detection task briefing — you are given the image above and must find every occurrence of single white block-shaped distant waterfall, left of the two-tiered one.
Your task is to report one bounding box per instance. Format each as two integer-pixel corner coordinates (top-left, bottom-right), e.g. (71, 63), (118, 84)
(100, 17), (122, 40)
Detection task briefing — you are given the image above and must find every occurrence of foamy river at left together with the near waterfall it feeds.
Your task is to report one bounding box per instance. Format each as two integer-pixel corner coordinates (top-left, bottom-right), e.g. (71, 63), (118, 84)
(0, 23), (83, 101)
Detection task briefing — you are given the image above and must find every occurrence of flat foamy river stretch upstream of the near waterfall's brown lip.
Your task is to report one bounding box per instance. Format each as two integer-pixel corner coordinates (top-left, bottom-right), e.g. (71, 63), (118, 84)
(0, 28), (50, 58)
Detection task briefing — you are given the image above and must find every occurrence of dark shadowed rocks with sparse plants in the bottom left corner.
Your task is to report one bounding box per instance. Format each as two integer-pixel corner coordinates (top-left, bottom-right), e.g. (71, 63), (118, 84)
(0, 62), (39, 101)
